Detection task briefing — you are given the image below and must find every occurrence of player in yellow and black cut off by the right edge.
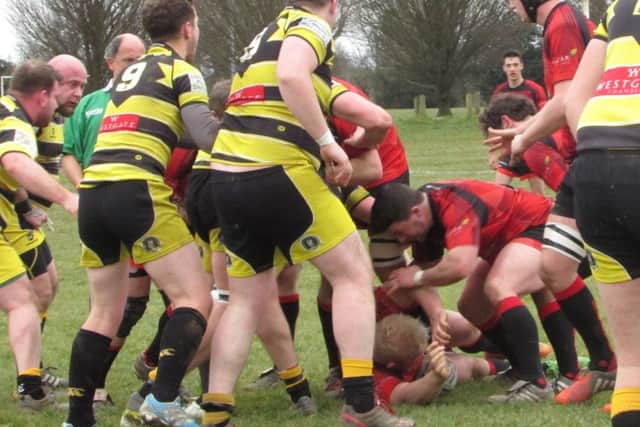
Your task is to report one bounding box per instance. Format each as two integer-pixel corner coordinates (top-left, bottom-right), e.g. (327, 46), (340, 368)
(566, 0), (640, 427)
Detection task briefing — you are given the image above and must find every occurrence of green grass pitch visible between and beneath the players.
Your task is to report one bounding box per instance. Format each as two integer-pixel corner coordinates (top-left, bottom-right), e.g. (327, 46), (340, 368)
(0, 110), (609, 427)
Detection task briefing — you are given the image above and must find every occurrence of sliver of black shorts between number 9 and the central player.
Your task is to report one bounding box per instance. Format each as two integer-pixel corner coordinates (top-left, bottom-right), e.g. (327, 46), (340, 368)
(186, 169), (219, 244)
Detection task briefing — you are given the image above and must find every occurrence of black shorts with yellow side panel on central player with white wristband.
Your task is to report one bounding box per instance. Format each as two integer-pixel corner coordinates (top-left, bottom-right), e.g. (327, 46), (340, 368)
(209, 165), (355, 278)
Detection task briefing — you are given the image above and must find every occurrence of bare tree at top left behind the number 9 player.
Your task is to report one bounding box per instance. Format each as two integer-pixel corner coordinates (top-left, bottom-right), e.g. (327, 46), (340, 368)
(9, 0), (142, 90)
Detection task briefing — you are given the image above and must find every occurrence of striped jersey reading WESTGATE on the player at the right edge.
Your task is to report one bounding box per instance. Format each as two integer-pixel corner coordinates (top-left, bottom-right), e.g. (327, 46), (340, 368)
(578, 0), (640, 151)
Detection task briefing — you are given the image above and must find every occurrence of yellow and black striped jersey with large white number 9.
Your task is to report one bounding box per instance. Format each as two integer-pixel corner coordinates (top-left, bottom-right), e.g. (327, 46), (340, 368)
(81, 44), (208, 187)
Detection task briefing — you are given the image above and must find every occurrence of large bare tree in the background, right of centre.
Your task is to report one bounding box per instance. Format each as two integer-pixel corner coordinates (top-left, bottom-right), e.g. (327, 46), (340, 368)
(360, 0), (522, 115)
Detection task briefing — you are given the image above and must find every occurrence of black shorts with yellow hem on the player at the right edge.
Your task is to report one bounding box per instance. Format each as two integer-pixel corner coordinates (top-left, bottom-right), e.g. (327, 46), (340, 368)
(572, 150), (640, 283)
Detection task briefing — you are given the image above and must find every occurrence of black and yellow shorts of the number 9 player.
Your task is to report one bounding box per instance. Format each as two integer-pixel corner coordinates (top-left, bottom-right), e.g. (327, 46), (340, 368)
(78, 180), (193, 268)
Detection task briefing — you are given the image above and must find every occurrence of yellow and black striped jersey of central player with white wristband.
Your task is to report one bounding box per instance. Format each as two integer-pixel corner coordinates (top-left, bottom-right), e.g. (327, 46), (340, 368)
(212, 6), (335, 168)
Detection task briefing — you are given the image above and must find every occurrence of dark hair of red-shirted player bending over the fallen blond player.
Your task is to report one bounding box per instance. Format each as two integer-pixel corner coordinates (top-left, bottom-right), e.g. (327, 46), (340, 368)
(369, 183), (423, 234)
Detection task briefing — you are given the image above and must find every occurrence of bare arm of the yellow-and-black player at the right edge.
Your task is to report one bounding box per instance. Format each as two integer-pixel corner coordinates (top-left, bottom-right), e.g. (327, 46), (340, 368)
(565, 38), (607, 136)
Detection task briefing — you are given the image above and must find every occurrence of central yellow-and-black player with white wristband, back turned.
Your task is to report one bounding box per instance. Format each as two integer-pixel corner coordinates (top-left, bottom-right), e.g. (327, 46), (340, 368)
(203, 0), (414, 426)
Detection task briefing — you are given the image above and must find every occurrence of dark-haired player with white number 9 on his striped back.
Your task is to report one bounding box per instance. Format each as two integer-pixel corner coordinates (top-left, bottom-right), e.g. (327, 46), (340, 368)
(63, 0), (217, 427)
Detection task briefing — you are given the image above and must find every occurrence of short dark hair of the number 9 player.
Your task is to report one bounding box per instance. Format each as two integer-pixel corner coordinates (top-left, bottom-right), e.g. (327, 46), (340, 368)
(142, 0), (196, 42)
